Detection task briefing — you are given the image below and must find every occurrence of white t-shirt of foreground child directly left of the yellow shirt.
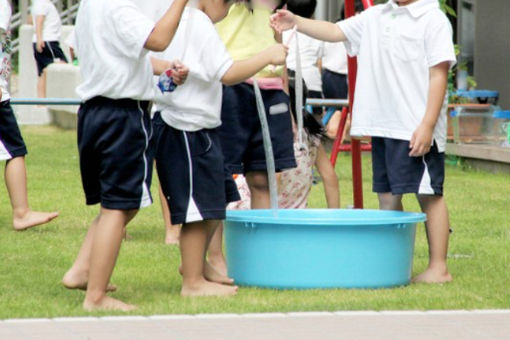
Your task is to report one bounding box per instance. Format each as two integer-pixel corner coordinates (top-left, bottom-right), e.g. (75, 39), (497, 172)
(151, 7), (233, 131)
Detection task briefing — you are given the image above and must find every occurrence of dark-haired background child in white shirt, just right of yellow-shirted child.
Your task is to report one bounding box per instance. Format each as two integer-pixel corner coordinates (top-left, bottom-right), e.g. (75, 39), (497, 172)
(283, 0), (324, 115)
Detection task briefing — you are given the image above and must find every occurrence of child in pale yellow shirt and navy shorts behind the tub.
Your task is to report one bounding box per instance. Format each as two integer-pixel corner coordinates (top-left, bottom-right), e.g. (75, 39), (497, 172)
(216, 0), (296, 209)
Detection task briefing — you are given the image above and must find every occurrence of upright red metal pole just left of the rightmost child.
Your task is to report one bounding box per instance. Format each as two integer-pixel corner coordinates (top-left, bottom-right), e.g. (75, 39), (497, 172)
(345, 0), (373, 209)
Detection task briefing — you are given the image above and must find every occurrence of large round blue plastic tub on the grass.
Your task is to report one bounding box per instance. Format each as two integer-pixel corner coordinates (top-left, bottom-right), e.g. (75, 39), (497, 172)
(225, 209), (426, 289)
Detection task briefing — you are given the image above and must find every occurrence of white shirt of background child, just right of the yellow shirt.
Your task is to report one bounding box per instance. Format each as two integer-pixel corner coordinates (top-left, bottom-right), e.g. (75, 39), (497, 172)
(283, 31), (324, 92)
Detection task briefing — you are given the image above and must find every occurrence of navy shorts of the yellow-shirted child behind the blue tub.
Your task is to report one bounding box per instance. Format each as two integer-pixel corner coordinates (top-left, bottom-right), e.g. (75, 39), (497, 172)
(219, 83), (296, 174)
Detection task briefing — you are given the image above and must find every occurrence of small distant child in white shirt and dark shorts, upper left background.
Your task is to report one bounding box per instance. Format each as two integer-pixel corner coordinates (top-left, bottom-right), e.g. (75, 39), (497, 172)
(31, 0), (67, 98)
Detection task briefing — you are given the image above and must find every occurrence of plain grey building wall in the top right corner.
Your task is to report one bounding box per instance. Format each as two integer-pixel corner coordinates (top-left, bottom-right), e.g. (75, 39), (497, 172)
(474, 0), (510, 110)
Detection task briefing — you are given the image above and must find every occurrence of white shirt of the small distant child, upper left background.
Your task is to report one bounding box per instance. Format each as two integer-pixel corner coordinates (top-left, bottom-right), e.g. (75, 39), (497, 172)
(30, 0), (62, 42)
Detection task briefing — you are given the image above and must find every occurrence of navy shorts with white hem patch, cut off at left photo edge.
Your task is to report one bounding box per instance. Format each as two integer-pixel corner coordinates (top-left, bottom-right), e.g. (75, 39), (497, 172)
(0, 100), (27, 161)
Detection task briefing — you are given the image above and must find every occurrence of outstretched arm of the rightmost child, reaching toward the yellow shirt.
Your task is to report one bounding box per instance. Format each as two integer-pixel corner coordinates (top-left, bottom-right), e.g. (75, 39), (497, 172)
(271, 9), (347, 42)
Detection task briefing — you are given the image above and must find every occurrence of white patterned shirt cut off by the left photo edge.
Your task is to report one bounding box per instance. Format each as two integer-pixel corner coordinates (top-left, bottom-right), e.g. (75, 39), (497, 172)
(0, 0), (12, 101)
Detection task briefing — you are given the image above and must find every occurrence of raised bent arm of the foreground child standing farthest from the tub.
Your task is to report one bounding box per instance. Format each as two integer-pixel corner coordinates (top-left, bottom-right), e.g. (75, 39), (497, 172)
(144, 0), (188, 52)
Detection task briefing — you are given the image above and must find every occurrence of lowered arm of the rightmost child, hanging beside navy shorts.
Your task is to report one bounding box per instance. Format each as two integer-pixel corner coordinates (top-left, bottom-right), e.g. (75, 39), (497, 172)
(409, 61), (450, 157)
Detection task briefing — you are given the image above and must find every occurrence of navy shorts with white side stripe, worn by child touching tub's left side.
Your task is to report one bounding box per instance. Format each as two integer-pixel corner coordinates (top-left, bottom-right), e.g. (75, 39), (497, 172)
(153, 112), (241, 224)
